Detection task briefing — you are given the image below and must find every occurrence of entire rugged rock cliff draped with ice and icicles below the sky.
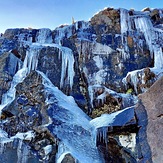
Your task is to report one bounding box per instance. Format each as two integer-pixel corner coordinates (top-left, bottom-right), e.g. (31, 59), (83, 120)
(0, 8), (163, 163)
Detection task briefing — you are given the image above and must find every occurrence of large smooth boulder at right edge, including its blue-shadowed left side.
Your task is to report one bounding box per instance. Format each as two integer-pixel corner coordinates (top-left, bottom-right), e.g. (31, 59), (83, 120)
(136, 78), (163, 163)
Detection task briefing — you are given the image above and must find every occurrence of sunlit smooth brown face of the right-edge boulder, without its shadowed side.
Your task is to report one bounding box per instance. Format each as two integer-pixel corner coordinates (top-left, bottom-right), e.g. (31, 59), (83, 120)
(139, 77), (163, 163)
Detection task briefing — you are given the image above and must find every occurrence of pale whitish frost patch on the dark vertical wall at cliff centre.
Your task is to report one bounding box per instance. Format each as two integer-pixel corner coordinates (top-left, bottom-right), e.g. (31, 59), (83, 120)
(78, 41), (114, 86)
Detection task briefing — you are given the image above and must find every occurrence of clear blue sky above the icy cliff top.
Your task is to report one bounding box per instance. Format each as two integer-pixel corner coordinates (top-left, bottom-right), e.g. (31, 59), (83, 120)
(0, 0), (163, 33)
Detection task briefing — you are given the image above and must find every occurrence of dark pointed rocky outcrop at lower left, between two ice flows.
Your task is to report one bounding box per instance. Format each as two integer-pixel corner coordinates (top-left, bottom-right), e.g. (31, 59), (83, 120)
(1, 72), (58, 161)
